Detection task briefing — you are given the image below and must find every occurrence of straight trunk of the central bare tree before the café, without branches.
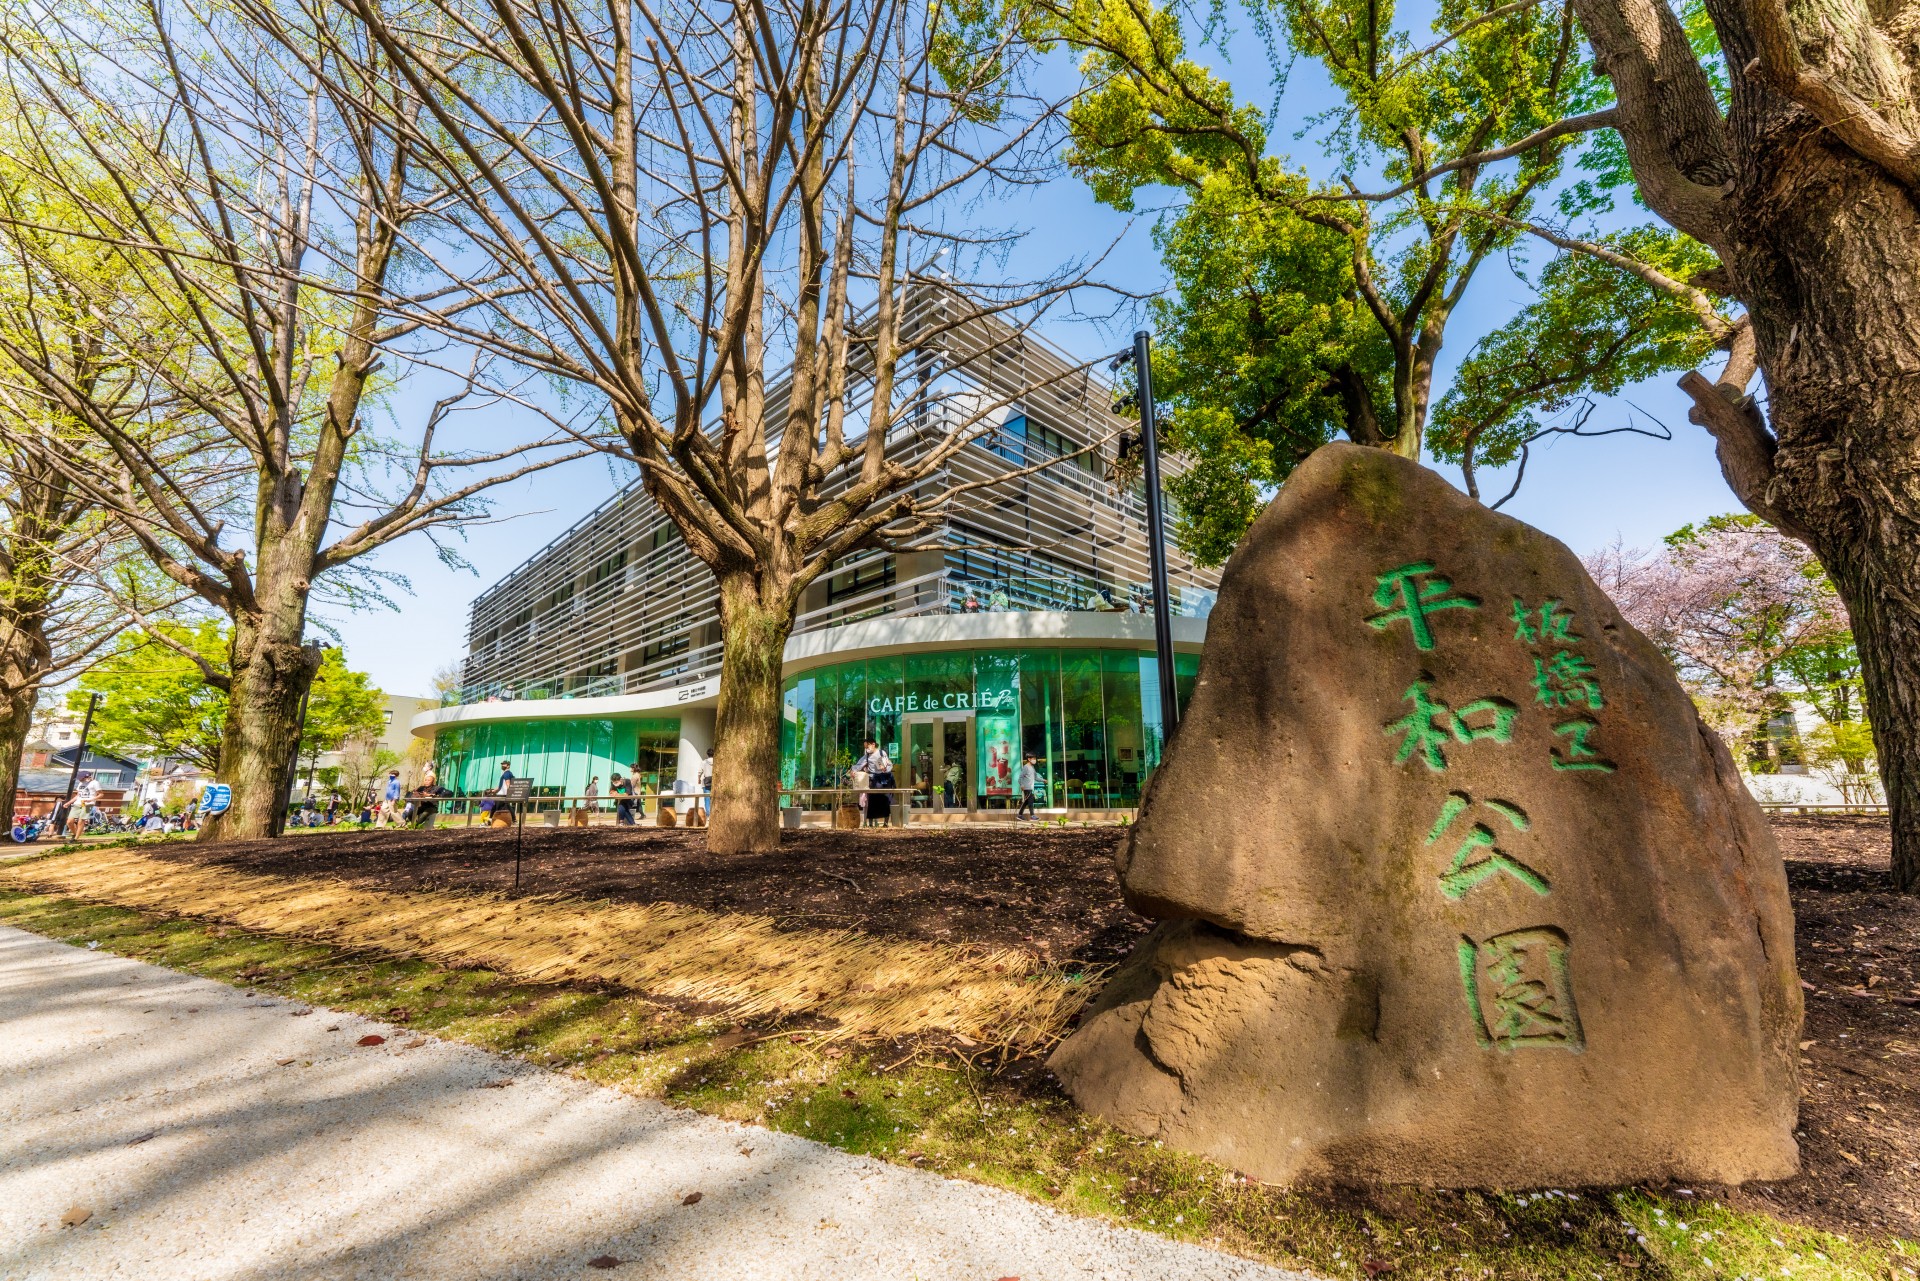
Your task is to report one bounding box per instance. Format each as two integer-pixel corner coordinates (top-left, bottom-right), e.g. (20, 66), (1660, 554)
(707, 574), (793, 855)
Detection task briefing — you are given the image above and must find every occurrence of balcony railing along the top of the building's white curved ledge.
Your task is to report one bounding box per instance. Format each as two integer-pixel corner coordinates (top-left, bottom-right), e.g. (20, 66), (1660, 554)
(440, 570), (1219, 707)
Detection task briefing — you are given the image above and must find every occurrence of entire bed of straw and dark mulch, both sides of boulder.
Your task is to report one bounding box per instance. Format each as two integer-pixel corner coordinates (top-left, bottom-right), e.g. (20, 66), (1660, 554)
(11, 818), (1920, 1259)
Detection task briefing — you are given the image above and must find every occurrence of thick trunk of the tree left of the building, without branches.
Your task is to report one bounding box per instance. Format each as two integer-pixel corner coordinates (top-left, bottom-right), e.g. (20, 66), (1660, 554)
(198, 592), (319, 841)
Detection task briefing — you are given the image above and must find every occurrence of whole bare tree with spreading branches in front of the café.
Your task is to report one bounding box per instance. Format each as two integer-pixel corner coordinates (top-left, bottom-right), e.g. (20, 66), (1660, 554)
(330, 0), (1113, 851)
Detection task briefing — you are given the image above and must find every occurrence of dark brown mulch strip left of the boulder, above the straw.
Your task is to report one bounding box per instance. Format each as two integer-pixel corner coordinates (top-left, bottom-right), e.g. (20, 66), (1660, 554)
(148, 820), (1152, 966)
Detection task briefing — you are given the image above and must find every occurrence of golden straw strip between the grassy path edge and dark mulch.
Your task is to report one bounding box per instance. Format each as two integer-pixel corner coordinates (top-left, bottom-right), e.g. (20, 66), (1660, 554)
(0, 847), (1098, 1052)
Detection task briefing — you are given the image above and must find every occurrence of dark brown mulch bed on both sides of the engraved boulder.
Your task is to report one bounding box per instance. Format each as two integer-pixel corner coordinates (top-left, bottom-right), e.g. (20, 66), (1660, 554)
(123, 816), (1920, 1237)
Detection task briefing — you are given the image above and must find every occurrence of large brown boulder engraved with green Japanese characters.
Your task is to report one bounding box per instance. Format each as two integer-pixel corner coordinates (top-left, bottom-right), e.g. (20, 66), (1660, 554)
(1052, 446), (1801, 1187)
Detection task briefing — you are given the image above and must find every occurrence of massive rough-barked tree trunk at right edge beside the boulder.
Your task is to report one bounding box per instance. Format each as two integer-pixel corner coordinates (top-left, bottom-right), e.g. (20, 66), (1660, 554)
(1722, 90), (1920, 891)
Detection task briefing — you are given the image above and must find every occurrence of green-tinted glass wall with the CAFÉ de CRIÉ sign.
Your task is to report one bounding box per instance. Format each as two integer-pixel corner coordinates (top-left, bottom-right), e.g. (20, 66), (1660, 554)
(781, 649), (1200, 809)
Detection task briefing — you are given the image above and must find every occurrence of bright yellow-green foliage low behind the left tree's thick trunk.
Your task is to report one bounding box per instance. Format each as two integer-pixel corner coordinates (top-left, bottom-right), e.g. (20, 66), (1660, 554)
(67, 618), (386, 770)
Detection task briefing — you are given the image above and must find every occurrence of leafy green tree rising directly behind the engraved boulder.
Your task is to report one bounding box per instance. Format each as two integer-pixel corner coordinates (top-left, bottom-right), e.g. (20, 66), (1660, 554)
(1054, 0), (1743, 563)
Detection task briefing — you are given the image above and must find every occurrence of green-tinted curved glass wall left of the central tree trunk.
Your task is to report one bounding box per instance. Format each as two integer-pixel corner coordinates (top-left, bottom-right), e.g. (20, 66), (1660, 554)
(434, 716), (680, 797)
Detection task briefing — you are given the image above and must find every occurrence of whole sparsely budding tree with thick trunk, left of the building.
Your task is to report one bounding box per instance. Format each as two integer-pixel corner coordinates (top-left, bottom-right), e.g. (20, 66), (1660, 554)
(0, 0), (588, 839)
